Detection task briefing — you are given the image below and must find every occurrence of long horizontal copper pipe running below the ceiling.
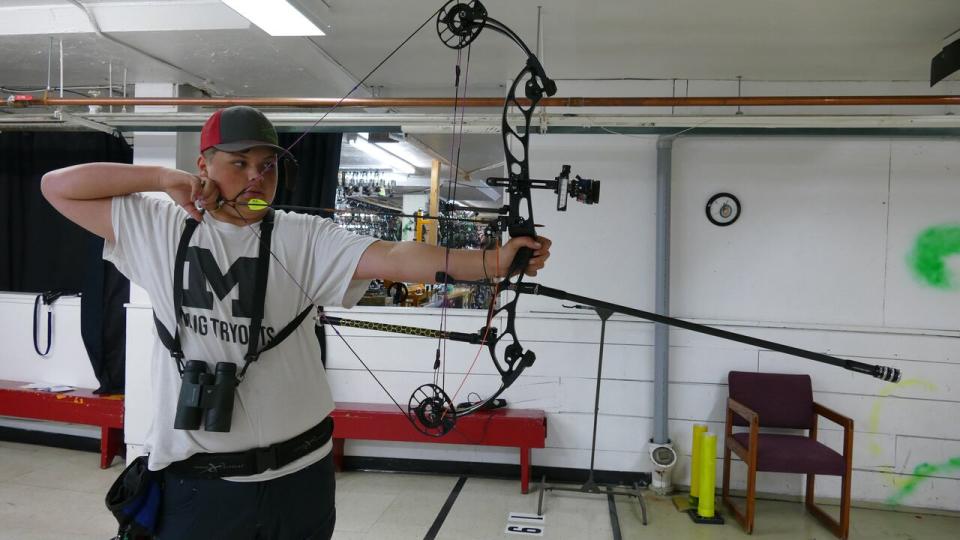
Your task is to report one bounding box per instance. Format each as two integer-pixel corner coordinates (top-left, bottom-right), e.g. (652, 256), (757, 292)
(7, 95), (960, 108)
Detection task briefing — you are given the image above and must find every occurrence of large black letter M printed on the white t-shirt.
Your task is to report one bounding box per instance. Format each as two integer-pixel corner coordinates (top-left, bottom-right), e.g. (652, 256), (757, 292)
(183, 246), (257, 318)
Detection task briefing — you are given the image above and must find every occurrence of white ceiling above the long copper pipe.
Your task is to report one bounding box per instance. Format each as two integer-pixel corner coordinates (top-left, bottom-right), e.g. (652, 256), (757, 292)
(0, 0), (960, 97)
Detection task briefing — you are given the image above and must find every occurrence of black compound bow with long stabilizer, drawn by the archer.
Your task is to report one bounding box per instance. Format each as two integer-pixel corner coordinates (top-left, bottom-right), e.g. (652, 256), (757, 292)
(225, 0), (900, 436)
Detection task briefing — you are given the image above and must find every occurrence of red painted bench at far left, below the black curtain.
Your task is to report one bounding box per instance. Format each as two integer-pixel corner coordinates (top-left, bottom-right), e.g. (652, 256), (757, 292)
(0, 379), (124, 469)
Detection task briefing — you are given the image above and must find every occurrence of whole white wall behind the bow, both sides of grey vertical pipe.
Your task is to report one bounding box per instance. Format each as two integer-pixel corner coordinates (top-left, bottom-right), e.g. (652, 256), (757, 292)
(320, 135), (960, 509)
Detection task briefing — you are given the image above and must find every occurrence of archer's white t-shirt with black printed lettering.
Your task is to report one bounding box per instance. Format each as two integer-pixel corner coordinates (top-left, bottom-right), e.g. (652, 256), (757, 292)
(103, 194), (376, 481)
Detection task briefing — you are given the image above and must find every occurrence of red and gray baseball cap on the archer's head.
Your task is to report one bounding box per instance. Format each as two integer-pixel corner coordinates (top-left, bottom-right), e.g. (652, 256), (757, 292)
(200, 105), (292, 157)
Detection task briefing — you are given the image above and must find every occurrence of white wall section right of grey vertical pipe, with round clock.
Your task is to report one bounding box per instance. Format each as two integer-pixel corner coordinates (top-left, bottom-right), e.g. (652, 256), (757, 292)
(671, 137), (960, 509)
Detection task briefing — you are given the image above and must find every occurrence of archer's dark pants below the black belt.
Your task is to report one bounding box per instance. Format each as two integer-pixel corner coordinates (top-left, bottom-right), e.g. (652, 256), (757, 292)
(156, 455), (337, 540)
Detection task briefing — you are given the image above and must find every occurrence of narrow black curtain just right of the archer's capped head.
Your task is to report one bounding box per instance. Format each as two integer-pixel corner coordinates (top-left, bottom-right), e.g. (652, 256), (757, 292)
(274, 133), (343, 367)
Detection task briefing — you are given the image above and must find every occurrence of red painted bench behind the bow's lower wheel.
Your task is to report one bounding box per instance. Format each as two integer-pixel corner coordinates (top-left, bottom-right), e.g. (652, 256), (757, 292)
(331, 401), (547, 493)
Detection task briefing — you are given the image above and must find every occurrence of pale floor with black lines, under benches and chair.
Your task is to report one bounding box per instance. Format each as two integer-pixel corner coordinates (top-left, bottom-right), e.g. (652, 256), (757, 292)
(0, 441), (960, 540)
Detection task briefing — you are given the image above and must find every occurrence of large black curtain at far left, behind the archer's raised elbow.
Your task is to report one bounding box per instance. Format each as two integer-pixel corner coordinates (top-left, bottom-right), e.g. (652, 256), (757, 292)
(0, 131), (133, 393)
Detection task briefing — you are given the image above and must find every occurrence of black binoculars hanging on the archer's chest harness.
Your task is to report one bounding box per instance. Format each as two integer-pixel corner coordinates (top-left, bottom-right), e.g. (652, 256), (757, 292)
(173, 360), (237, 432)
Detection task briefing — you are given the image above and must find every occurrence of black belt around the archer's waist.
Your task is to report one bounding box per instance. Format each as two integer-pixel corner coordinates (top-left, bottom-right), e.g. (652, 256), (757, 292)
(167, 417), (333, 478)
